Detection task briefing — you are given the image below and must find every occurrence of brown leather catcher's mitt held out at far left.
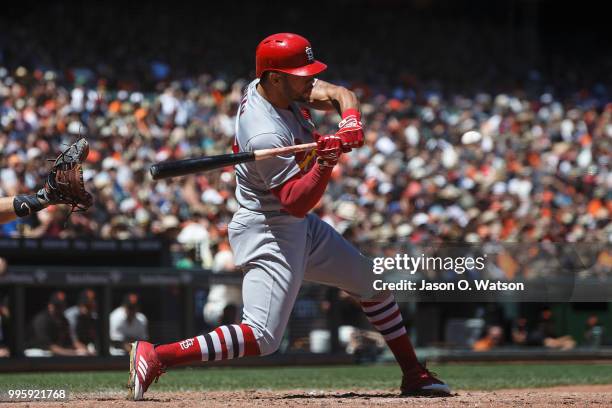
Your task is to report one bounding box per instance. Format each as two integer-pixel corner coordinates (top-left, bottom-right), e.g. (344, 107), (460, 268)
(37, 138), (93, 211)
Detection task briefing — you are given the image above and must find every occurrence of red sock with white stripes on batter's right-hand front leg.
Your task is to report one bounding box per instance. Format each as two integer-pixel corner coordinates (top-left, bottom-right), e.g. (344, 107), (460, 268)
(361, 295), (418, 373)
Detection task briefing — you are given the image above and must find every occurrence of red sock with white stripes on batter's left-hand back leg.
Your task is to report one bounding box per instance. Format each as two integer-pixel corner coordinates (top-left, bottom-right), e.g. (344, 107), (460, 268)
(155, 324), (260, 367)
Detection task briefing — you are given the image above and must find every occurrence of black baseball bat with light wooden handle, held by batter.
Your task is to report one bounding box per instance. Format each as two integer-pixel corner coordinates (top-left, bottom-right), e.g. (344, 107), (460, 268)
(149, 143), (317, 180)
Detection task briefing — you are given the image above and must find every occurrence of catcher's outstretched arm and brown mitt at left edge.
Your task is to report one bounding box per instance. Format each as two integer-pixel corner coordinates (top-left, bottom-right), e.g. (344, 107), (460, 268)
(0, 139), (93, 224)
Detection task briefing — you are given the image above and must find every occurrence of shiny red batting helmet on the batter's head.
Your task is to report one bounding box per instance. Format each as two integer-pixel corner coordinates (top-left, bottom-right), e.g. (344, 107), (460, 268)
(255, 33), (327, 78)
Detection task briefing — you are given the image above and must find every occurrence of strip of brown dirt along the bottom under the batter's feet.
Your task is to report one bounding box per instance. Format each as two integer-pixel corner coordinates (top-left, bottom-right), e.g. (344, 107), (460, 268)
(7, 384), (612, 408)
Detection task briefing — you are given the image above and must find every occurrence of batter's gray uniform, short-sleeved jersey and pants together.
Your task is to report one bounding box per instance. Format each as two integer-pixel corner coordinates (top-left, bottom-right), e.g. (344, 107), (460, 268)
(227, 80), (376, 354)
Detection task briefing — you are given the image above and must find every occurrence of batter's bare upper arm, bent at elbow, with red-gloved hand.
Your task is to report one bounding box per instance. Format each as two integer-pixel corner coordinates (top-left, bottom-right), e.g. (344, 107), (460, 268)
(305, 80), (364, 152)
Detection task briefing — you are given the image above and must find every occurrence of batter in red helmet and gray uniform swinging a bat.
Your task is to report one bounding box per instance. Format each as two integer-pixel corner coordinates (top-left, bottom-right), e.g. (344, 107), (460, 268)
(128, 33), (450, 400)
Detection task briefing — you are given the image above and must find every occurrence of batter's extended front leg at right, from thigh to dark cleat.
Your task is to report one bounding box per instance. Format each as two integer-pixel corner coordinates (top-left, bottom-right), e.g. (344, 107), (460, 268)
(304, 215), (450, 395)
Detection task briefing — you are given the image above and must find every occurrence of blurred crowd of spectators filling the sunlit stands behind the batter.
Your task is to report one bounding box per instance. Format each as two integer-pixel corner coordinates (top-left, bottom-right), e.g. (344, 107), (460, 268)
(0, 67), (612, 255)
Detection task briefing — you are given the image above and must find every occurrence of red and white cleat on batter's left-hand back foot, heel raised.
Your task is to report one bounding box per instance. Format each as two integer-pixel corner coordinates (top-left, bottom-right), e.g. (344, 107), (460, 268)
(128, 341), (165, 401)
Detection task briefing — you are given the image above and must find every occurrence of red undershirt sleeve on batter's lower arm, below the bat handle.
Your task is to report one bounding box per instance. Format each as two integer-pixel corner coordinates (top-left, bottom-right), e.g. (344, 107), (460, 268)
(270, 163), (332, 218)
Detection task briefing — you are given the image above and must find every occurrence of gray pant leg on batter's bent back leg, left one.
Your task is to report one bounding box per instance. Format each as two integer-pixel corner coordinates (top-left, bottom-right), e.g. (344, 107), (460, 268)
(230, 210), (309, 355)
